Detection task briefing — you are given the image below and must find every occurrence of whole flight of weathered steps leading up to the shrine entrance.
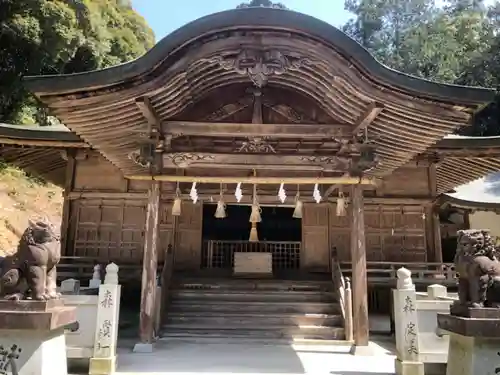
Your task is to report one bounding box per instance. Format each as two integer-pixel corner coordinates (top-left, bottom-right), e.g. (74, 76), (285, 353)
(161, 278), (345, 344)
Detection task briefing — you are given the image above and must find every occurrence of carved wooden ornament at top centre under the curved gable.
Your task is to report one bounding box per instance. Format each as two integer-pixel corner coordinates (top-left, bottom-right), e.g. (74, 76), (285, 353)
(208, 49), (313, 87)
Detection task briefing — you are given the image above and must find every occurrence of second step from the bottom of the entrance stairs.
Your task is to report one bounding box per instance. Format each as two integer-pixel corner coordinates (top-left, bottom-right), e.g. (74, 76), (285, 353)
(167, 312), (343, 327)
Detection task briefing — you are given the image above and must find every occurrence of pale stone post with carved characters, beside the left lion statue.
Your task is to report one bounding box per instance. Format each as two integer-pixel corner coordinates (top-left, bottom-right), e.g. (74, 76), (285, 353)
(89, 263), (121, 375)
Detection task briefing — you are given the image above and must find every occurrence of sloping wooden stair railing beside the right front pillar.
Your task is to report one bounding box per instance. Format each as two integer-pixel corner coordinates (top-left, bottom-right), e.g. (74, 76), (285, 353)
(330, 248), (354, 341)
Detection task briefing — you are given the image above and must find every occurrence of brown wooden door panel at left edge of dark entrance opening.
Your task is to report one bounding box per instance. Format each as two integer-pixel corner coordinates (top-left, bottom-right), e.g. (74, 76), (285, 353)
(174, 202), (203, 270)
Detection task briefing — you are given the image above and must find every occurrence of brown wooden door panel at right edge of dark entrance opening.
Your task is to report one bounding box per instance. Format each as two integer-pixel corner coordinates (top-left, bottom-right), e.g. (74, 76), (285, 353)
(301, 203), (330, 271)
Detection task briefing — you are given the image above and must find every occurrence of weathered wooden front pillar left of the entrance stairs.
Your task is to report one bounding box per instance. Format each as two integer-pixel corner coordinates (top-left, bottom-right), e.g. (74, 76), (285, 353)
(139, 181), (160, 344)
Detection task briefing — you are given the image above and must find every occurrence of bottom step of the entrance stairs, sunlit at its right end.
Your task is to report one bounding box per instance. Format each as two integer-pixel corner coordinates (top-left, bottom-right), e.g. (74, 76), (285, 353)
(160, 326), (345, 340)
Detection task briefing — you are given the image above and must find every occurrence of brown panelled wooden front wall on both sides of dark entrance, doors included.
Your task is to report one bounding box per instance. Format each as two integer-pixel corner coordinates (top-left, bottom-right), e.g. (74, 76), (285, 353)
(67, 151), (434, 270)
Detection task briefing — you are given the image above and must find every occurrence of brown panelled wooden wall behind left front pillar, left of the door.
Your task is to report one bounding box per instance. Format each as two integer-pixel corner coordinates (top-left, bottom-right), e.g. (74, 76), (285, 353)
(65, 154), (174, 263)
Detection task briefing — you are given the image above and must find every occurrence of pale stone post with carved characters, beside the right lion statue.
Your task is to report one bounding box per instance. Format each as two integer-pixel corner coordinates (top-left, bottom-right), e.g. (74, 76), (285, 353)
(392, 268), (424, 375)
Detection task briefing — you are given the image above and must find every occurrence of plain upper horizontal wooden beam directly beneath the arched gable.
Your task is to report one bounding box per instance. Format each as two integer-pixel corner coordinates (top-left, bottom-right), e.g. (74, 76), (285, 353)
(161, 121), (352, 139)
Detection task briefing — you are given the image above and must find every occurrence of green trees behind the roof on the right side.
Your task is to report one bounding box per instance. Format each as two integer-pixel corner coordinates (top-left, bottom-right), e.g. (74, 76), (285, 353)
(343, 0), (500, 135)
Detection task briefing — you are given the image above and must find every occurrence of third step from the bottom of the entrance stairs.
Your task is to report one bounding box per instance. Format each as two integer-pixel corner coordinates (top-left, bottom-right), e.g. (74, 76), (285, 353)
(168, 299), (341, 314)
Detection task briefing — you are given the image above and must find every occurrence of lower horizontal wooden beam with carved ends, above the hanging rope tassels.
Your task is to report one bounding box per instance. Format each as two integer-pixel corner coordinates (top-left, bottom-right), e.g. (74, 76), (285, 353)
(163, 152), (377, 173)
